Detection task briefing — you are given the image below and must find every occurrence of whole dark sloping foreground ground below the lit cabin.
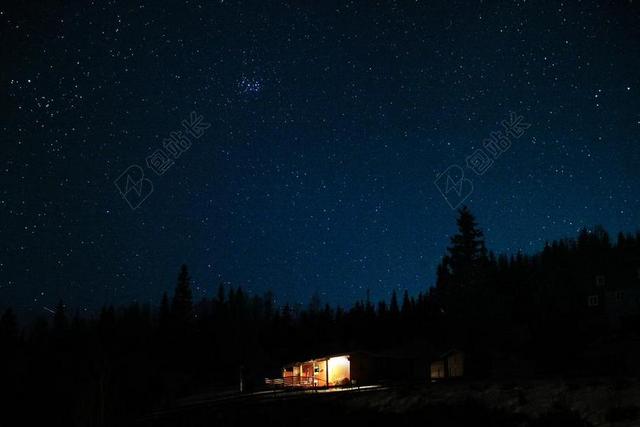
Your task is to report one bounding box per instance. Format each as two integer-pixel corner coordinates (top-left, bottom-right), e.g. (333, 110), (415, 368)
(137, 379), (640, 427)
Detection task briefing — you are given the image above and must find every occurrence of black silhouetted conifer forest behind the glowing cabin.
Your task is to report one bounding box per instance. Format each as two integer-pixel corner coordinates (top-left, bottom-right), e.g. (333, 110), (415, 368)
(0, 208), (640, 426)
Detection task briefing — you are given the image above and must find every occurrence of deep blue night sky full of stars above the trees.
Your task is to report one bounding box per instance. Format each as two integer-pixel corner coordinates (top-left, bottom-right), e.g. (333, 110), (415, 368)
(0, 0), (640, 313)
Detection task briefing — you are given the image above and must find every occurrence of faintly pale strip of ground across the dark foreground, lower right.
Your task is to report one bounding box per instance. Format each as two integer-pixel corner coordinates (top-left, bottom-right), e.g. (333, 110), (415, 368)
(350, 378), (640, 426)
